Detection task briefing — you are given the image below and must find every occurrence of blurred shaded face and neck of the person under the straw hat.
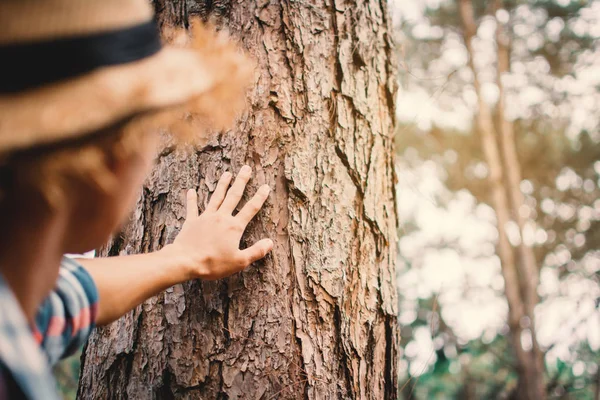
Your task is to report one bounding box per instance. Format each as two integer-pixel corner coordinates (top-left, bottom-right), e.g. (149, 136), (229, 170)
(0, 132), (159, 319)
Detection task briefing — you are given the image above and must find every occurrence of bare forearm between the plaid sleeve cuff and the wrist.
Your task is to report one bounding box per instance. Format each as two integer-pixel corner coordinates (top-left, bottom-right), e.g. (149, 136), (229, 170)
(78, 246), (193, 326)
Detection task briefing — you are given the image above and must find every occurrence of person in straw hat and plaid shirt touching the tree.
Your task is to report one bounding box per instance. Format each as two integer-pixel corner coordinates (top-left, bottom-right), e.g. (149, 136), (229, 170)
(0, 0), (273, 400)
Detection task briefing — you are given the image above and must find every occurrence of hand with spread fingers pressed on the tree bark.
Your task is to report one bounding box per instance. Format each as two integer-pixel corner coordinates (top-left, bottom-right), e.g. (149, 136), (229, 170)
(163, 165), (273, 279)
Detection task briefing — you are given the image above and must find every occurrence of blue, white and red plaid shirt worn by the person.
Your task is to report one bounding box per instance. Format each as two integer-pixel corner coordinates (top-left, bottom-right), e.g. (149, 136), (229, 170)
(0, 258), (98, 400)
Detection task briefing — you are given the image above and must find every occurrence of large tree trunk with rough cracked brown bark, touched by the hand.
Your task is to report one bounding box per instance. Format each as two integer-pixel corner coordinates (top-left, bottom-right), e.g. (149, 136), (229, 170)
(79, 0), (399, 400)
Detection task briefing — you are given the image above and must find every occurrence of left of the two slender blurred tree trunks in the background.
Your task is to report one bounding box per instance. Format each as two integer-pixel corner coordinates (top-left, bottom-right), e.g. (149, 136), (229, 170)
(458, 0), (546, 400)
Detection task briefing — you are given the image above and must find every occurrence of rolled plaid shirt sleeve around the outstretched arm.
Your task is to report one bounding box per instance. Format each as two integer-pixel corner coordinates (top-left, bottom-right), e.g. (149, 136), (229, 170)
(33, 257), (98, 365)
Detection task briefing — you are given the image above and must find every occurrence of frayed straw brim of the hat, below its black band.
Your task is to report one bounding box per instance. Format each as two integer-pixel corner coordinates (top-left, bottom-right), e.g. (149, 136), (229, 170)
(0, 30), (252, 152)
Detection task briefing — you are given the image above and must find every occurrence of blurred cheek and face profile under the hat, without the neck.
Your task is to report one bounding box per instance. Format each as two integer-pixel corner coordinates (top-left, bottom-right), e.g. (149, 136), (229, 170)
(67, 133), (159, 254)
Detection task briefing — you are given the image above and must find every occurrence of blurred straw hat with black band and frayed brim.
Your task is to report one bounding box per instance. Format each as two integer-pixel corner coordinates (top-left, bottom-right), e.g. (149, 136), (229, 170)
(0, 0), (252, 153)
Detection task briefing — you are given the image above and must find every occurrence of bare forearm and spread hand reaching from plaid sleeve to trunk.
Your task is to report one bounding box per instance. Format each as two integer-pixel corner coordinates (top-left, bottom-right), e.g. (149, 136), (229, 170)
(78, 166), (273, 325)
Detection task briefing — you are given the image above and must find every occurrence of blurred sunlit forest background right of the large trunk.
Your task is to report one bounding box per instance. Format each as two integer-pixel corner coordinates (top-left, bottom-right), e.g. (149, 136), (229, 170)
(391, 0), (600, 399)
